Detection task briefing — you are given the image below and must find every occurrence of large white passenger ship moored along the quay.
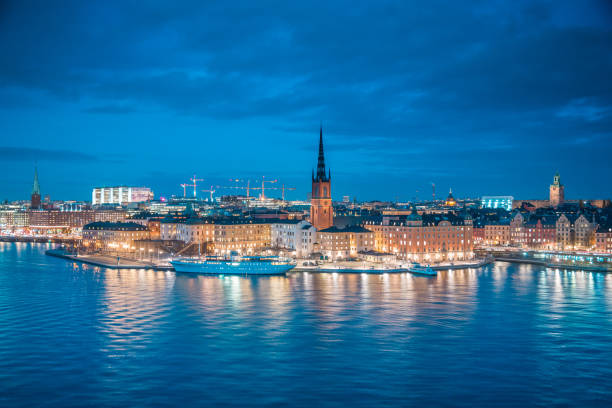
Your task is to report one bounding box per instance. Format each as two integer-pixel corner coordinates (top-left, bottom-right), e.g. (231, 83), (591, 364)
(170, 255), (295, 275)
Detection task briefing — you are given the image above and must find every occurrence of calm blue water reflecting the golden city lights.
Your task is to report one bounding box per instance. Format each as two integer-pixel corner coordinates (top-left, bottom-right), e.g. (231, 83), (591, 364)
(0, 243), (612, 407)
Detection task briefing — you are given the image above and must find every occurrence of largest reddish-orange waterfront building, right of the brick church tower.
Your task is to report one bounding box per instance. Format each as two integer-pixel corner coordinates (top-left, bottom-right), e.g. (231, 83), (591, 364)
(364, 207), (474, 262)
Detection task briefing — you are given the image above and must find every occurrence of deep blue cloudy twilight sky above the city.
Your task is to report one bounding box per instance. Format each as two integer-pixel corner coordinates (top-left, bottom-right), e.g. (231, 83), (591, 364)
(0, 0), (612, 200)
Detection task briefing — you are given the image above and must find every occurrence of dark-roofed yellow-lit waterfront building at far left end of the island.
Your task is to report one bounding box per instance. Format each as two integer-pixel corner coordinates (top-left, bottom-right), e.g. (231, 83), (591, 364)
(82, 222), (149, 253)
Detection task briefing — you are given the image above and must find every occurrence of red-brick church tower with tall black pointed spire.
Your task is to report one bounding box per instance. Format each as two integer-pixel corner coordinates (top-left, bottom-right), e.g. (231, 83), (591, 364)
(310, 126), (334, 231)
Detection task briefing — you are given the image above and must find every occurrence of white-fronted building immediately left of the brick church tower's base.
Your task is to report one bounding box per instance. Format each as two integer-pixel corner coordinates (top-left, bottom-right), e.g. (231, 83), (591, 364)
(270, 220), (317, 258)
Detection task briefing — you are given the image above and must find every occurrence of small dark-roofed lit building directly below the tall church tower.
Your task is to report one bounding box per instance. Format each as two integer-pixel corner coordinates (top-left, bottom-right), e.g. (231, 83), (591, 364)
(317, 225), (375, 260)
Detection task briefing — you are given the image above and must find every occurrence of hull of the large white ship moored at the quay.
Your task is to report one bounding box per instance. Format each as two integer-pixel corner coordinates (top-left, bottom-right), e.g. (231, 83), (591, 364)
(170, 260), (295, 275)
